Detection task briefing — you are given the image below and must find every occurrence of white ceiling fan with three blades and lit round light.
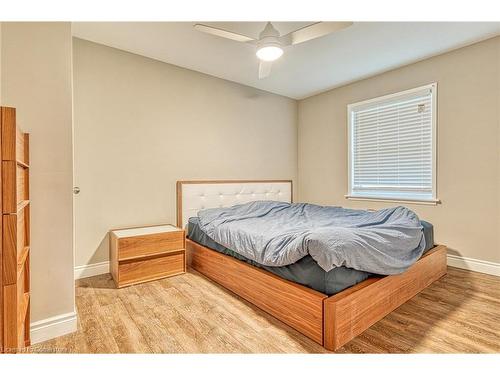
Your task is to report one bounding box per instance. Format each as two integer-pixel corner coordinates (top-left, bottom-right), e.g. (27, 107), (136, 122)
(194, 22), (352, 79)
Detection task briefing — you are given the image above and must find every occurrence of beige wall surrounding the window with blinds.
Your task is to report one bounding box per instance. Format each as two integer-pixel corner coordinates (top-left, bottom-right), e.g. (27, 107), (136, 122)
(298, 37), (500, 262)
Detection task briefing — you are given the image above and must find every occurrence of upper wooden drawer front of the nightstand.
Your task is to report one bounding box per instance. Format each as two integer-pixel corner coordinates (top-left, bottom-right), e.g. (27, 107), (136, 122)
(118, 231), (184, 260)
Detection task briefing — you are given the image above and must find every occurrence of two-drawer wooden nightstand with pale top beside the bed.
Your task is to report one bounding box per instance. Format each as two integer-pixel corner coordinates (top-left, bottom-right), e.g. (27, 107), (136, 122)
(109, 224), (186, 288)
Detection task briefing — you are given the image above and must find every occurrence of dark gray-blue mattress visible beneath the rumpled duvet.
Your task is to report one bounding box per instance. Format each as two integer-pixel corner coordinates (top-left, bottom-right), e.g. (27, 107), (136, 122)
(188, 217), (434, 295)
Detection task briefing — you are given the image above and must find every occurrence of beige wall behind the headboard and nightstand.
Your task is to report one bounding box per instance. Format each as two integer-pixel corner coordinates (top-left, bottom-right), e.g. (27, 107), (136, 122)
(73, 39), (297, 266)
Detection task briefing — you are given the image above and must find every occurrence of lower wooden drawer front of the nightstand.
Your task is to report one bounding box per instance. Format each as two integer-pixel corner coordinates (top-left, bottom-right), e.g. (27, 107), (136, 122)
(118, 250), (186, 286)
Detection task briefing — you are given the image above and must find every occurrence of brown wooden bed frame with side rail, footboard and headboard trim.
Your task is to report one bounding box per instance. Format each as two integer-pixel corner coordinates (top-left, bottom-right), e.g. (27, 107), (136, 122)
(177, 181), (446, 351)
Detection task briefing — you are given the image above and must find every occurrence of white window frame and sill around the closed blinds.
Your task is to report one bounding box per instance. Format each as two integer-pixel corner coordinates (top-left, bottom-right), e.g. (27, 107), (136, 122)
(345, 82), (440, 205)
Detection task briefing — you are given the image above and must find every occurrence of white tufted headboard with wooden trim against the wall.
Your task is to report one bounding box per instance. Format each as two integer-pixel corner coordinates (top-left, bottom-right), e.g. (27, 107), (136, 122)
(177, 180), (293, 228)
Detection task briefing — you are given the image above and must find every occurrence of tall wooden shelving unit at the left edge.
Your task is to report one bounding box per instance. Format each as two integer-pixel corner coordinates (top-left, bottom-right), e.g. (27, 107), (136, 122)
(0, 107), (30, 352)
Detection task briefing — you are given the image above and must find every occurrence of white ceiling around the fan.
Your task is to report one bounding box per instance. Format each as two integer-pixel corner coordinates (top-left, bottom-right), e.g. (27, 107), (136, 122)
(73, 22), (500, 99)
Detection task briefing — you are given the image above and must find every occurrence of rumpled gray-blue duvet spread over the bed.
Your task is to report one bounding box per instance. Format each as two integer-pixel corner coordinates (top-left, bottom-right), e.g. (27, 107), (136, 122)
(198, 201), (425, 275)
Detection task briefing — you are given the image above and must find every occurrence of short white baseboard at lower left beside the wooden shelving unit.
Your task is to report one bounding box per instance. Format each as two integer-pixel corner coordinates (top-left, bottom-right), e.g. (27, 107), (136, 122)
(30, 312), (77, 345)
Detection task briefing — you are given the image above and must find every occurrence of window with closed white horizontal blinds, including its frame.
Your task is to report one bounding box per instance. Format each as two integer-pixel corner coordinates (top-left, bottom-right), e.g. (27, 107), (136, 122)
(347, 83), (437, 203)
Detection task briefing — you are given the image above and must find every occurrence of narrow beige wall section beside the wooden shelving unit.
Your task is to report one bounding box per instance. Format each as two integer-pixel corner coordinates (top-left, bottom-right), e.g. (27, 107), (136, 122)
(1, 22), (74, 322)
